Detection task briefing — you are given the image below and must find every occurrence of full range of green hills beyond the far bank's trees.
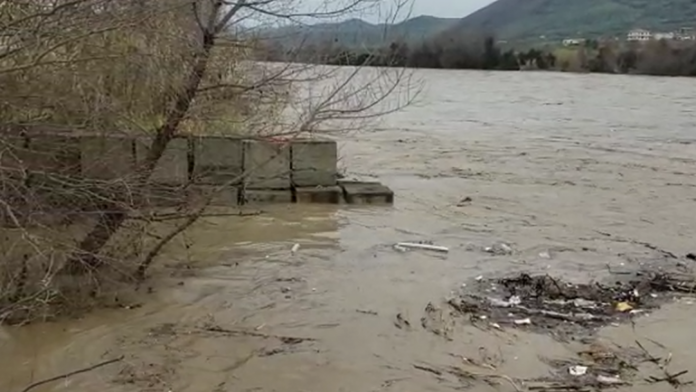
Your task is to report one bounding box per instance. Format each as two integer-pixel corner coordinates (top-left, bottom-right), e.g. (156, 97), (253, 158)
(261, 0), (696, 47)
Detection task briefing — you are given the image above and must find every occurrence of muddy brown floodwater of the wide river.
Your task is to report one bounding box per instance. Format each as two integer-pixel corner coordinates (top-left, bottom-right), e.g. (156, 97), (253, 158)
(0, 71), (696, 392)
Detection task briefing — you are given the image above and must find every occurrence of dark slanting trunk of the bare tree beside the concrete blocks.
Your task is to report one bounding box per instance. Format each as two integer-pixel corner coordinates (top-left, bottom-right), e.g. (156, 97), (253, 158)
(66, 31), (215, 273)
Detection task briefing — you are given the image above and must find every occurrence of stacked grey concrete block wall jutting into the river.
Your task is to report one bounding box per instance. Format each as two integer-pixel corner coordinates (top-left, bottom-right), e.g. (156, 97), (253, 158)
(3, 135), (393, 205)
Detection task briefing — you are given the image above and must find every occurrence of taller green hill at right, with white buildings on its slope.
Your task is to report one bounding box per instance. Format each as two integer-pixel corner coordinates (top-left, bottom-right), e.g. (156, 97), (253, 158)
(453, 0), (696, 40)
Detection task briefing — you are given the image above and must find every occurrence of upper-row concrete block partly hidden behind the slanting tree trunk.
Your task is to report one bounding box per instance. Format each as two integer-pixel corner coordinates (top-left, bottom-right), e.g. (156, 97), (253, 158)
(135, 137), (189, 185)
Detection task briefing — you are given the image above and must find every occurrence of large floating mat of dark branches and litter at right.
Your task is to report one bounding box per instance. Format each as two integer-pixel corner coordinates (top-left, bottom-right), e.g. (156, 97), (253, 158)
(447, 271), (696, 340)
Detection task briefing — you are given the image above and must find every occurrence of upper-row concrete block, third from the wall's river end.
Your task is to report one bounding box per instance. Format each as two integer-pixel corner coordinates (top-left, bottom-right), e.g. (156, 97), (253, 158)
(193, 137), (244, 185)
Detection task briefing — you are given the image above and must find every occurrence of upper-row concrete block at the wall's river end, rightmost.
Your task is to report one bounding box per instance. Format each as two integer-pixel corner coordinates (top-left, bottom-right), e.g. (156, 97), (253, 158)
(291, 139), (338, 187)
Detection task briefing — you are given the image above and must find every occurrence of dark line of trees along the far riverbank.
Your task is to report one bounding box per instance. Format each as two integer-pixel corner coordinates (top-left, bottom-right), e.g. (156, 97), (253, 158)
(261, 35), (696, 76)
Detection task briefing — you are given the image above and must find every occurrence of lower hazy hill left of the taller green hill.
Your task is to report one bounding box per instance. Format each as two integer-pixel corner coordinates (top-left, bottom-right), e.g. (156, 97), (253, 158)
(260, 16), (460, 46)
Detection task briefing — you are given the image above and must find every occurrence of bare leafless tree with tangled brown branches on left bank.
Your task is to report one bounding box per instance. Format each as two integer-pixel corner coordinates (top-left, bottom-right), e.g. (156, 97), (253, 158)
(0, 0), (413, 321)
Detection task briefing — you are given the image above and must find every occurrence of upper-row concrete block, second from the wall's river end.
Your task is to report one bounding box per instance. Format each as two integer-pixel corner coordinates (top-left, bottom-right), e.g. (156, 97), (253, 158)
(244, 140), (290, 189)
